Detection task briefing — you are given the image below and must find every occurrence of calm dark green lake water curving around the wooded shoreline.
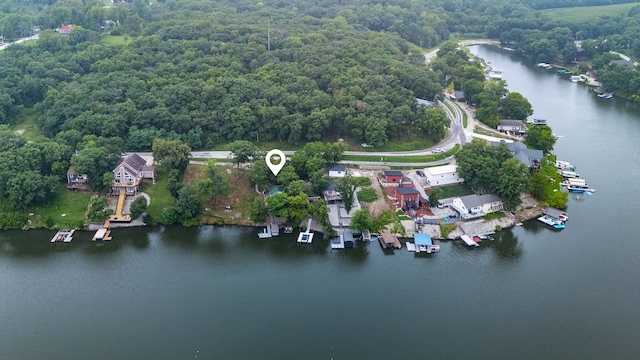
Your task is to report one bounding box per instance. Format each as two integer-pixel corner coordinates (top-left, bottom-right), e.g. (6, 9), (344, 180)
(0, 47), (640, 359)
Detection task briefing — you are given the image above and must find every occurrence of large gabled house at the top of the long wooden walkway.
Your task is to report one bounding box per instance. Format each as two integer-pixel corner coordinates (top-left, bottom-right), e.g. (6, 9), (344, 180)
(111, 154), (156, 195)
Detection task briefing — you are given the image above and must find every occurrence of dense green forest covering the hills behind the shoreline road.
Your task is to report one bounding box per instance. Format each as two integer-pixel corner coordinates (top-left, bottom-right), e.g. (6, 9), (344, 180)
(0, 0), (640, 214)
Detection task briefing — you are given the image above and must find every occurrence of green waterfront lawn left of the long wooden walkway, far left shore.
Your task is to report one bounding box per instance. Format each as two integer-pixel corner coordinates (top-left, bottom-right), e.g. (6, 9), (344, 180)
(25, 184), (92, 229)
